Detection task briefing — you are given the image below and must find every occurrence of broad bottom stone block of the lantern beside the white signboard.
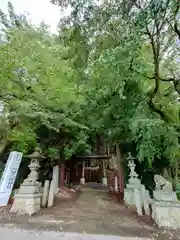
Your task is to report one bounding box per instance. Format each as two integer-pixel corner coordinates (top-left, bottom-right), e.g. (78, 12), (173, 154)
(10, 193), (42, 216)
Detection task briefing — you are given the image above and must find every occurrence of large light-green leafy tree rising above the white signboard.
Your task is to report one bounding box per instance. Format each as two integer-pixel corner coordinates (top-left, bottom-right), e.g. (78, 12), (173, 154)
(0, 1), (90, 162)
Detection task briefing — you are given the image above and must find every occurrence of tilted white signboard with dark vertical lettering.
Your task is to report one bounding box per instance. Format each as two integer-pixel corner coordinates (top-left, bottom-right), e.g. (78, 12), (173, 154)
(0, 152), (23, 206)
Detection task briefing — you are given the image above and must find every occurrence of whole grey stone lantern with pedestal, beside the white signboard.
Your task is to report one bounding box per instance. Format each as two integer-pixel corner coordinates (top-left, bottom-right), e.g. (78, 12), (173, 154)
(11, 147), (45, 215)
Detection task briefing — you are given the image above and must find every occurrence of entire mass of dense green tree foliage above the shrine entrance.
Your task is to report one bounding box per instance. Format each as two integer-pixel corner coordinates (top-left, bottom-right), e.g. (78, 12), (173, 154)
(0, 0), (180, 183)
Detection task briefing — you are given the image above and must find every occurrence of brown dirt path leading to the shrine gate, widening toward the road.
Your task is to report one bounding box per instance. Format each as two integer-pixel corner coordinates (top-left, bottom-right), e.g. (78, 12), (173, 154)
(1, 189), (180, 240)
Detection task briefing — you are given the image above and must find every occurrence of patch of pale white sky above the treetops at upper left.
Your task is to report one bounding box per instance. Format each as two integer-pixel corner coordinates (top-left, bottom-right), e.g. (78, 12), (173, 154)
(0, 0), (62, 33)
